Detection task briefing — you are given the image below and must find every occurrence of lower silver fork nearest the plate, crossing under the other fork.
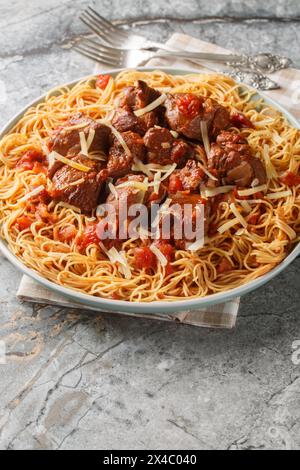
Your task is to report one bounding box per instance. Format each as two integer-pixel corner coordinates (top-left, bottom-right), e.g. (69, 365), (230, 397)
(73, 39), (279, 90)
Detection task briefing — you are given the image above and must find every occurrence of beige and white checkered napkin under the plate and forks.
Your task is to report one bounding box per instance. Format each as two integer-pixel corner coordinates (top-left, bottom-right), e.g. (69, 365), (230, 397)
(17, 34), (300, 328)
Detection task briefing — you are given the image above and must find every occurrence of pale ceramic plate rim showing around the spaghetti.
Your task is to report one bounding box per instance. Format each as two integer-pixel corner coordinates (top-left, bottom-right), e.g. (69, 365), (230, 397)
(0, 67), (300, 314)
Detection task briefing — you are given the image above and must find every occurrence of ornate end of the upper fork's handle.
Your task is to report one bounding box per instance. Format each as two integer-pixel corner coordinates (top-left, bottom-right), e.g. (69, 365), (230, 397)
(227, 52), (292, 73)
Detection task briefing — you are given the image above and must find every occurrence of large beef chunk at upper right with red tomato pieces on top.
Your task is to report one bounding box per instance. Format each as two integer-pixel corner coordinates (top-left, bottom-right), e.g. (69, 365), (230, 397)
(164, 93), (230, 142)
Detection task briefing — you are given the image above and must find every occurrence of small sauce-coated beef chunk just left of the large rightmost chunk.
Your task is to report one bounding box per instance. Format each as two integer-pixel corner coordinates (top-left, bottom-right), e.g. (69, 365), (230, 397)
(169, 160), (204, 192)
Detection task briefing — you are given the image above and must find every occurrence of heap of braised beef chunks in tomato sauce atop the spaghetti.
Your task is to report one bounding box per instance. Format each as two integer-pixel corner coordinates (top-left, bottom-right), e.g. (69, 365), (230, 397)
(19, 80), (267, 253)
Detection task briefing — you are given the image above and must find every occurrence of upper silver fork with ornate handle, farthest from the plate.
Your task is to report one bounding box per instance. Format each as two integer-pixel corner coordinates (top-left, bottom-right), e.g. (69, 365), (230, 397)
(80, 6), (292, 73)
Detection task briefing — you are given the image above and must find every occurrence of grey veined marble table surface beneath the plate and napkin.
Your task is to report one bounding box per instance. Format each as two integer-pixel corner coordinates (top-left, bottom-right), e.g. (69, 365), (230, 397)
(0, 0), (300, 449)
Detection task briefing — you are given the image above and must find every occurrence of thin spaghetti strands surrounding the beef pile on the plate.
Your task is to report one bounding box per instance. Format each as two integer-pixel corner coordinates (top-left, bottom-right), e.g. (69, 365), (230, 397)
(0, 70), (300, 302)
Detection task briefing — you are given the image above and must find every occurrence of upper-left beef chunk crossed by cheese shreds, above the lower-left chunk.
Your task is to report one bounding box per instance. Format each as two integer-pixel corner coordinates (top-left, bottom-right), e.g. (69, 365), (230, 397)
(49, 116), (111, 157)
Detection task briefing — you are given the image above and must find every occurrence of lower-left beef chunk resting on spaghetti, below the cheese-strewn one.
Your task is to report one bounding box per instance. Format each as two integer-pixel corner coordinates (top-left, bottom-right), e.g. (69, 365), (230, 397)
(50, 155), (101, 214)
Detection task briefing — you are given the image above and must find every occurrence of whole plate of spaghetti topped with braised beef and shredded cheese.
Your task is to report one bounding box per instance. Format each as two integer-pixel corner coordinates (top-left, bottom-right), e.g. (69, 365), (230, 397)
(0, 68), (300, 313)
